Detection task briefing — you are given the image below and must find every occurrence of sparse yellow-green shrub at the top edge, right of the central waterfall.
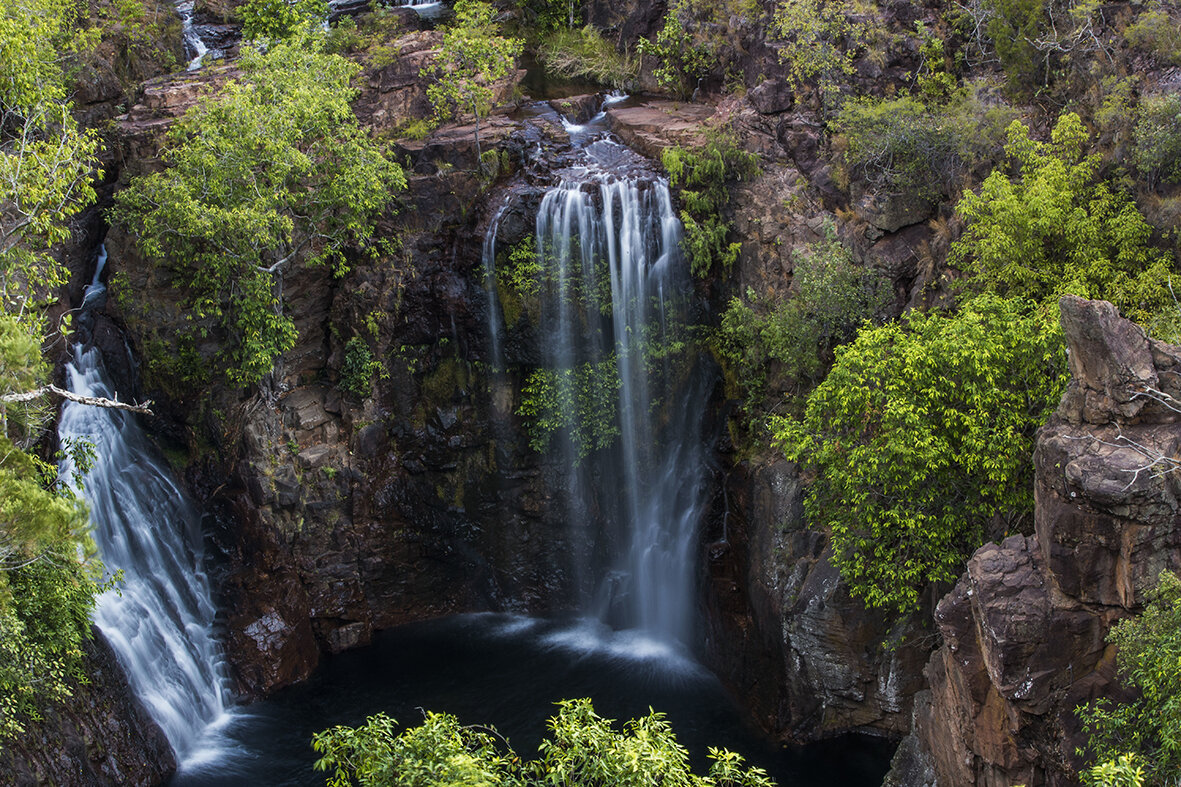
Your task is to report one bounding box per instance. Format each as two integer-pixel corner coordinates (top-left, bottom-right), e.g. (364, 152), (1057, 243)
(772, 0), (872, 93)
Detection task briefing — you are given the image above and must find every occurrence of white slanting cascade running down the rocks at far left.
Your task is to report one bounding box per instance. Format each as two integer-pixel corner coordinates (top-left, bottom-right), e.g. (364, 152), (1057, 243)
(58, 249), (230, 765)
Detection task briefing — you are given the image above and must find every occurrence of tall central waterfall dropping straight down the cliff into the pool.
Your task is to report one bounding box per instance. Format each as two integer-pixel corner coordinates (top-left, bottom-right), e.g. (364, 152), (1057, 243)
(519, 139), (705, 643)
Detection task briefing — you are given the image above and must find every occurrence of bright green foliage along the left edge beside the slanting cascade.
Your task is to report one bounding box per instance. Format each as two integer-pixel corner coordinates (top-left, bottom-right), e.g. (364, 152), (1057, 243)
(0, 0), (109, 740)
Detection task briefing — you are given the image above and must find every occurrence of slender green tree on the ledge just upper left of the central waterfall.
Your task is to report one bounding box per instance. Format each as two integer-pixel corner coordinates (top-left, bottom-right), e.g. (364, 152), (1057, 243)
(423, 0), (524, 168)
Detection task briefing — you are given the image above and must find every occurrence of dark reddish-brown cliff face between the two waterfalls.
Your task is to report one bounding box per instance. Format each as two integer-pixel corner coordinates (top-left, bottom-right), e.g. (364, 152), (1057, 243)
(99, 42), (609, 695)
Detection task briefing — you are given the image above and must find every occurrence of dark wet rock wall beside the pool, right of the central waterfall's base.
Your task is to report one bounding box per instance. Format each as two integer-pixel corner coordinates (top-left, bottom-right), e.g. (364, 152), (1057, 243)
(707, 458), (931, 740)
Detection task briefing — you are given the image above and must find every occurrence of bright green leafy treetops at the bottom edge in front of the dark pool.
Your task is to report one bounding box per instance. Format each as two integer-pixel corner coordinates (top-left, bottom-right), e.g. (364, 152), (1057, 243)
(312, 700), (774, 787)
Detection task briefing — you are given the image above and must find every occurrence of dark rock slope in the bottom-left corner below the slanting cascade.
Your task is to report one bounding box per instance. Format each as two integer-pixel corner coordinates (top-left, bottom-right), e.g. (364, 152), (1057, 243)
(0, 629), (176, 787)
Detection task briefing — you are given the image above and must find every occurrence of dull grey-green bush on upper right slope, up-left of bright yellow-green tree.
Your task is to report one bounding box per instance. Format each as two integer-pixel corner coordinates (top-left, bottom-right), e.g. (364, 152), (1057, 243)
(833, 87), (1013, 200)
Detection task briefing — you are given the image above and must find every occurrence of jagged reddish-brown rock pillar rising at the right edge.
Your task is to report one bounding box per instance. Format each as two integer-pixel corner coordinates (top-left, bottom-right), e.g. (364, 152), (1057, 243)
(915, 297), (1181, 787)
